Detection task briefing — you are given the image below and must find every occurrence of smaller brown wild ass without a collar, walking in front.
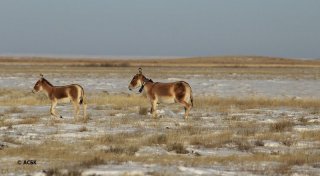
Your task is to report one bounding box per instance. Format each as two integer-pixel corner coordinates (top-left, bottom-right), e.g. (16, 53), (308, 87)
(32, 74), (87, 119)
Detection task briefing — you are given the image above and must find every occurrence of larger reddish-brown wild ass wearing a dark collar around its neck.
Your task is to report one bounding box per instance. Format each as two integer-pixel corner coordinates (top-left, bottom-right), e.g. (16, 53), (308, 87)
(128, 68), (193, 119)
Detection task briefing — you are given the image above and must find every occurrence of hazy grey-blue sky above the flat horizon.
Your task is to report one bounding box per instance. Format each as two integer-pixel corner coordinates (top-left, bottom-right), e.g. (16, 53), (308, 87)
(0, 0), (320, 58)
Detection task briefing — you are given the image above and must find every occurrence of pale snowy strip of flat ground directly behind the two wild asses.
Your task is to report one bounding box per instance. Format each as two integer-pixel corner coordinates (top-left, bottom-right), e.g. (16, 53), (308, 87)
(0, 74), (320, 98)
